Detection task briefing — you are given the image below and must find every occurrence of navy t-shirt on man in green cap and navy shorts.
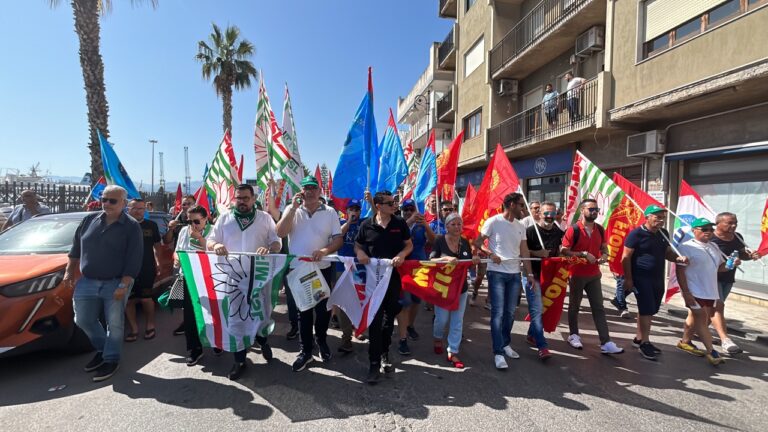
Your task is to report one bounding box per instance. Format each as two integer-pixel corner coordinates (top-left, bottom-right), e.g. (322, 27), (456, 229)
(624, 225), (669, 283)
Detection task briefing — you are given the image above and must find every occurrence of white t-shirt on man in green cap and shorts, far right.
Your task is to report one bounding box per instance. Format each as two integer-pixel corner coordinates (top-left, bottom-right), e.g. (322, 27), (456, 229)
(679, 238), (725, 300)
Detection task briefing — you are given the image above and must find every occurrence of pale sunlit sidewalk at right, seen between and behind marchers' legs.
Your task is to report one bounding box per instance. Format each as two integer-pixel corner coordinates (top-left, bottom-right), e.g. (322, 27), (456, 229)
(603, 273), (768, 346)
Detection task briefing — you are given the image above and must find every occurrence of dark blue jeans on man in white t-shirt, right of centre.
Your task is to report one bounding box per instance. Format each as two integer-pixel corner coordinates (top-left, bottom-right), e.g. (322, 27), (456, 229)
(488, 270), (522, 355)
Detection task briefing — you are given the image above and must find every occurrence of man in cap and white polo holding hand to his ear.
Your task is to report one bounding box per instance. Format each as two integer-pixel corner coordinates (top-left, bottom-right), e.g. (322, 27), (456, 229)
(277, 176), (344, 372)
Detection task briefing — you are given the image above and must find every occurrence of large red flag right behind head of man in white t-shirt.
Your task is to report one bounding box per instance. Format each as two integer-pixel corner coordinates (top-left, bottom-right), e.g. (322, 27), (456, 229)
(463, 144), (520, 240)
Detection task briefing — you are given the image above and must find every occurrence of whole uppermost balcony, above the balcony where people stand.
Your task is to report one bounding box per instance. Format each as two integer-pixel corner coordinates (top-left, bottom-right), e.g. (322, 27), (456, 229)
(489, 0), (606, 79)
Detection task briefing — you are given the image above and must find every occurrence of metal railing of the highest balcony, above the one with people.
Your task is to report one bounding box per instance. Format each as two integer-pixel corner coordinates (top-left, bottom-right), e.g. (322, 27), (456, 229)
(490, 0), (593, 75)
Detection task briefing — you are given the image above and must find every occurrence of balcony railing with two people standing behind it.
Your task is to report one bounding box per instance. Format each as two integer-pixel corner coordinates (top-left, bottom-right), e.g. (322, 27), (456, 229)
(488, 79), (600, 149)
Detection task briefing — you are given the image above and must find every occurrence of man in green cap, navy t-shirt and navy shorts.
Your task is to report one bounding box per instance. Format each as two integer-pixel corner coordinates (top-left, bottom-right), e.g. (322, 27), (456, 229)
(621, 205), (688, 360)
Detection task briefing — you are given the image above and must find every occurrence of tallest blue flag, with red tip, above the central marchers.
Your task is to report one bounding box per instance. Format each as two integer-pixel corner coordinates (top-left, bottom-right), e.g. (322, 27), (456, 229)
(332, 68), (379, 202)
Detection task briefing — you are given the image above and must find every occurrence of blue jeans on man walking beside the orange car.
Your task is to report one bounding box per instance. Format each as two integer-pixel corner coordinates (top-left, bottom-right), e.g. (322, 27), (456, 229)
(72, 277), (131, 363)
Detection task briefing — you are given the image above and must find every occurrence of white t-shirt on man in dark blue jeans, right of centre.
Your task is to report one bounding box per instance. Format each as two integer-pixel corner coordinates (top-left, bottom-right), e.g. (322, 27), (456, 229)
(480, 214), (526, 273)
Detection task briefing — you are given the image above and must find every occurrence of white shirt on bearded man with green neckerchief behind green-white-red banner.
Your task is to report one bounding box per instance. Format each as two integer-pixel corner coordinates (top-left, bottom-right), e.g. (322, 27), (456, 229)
(208, 210), (280, 253)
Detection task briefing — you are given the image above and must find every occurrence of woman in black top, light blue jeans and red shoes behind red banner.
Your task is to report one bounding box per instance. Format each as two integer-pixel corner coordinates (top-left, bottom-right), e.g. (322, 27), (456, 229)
(429, 213), (480, 369)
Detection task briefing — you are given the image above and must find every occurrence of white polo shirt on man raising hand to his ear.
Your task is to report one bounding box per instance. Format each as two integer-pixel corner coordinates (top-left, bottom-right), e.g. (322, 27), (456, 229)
(288, 204), (341, 269)
